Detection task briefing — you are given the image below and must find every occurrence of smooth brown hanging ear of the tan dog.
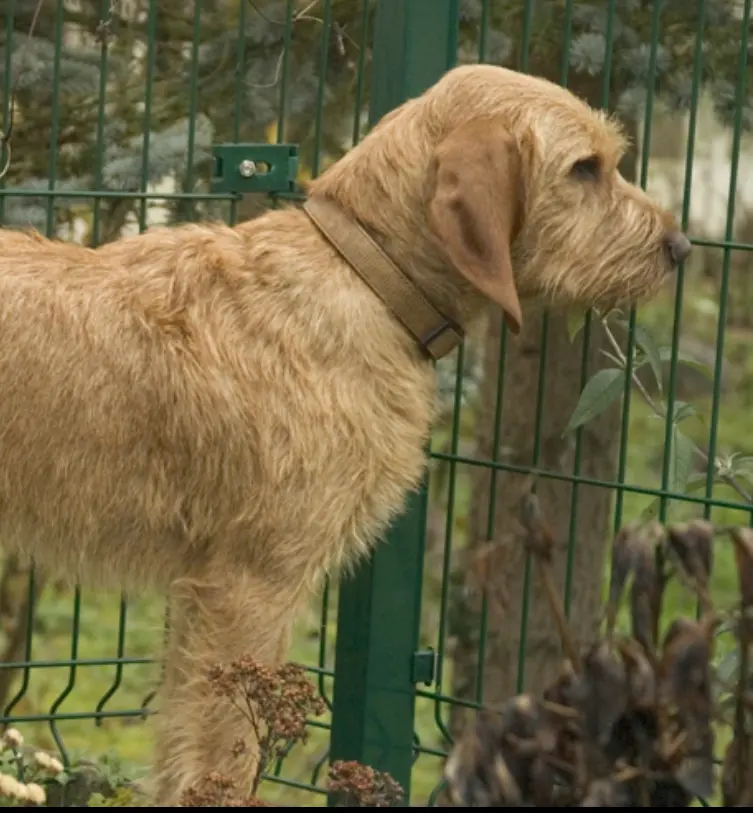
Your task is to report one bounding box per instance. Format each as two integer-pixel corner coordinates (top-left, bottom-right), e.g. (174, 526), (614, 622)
(429, 119), (523, 333)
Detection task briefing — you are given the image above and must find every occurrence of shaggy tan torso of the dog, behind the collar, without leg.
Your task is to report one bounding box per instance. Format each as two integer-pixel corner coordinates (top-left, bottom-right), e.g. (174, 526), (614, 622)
(0, 210), (433, 586)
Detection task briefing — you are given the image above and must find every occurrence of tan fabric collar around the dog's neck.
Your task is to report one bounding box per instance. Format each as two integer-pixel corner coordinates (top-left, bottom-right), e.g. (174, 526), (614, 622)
(303, 197), (463, 361)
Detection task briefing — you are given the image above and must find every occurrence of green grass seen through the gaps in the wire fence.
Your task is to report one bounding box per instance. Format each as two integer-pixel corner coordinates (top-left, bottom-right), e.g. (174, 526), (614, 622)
(1, 280), (753, 806)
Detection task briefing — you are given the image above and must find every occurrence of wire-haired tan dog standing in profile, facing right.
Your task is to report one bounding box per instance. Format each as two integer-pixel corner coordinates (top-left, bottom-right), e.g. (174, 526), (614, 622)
(0, 66), (689, 804)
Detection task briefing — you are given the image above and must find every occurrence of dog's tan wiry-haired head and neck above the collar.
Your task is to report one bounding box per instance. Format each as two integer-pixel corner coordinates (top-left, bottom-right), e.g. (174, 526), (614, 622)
(306, 65), (690, 332)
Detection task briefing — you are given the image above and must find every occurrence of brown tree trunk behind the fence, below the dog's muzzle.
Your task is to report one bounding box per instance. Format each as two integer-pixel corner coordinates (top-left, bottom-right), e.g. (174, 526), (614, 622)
(450, 77), (636, 735)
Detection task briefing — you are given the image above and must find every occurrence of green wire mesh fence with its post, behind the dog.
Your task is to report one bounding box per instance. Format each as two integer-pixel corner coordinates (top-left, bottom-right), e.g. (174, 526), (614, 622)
(0, 0), (753, 804)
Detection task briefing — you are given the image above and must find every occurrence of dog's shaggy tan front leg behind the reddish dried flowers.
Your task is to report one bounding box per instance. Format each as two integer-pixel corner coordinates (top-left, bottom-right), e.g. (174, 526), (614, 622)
(150, 576), (308, 806)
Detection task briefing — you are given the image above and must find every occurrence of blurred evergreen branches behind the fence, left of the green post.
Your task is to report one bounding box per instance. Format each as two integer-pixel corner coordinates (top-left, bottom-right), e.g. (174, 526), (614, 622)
(0, 0), (368, 236)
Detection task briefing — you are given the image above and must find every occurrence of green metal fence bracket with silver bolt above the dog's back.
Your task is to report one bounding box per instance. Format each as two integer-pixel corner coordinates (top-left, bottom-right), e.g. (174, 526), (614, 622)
(212, 144), (298, 195)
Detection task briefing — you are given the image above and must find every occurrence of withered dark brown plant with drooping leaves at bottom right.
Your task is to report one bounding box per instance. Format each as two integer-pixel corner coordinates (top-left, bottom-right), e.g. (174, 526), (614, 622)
(440, 521), (740, 807)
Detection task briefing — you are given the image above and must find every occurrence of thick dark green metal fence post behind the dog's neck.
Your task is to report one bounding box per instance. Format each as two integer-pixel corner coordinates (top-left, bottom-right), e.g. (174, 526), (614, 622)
(330, 0), (458, 804)
